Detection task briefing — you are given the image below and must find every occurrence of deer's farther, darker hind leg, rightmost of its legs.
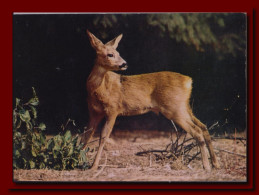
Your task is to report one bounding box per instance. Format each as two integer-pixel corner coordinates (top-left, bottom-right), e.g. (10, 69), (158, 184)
(190, 110), (220, 169)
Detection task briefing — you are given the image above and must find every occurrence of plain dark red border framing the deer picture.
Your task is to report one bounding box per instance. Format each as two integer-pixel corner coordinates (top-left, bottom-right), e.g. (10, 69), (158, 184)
(0, 0), (258, 194)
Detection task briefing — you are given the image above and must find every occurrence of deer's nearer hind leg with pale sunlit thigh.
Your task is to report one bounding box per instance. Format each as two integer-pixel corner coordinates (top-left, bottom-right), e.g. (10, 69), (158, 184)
(162, 110), (211, 171)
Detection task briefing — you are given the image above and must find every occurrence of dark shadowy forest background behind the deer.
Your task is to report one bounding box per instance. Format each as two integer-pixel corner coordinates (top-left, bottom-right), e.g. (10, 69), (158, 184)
(13, 13), (247, 133)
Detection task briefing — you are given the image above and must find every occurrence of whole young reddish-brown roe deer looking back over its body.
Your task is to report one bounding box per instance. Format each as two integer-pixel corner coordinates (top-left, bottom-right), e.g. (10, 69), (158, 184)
(82, 30), (219, 171)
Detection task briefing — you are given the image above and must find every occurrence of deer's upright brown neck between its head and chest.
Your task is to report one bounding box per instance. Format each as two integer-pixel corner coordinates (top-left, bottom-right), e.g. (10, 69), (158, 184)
(87, 62), (108, 92)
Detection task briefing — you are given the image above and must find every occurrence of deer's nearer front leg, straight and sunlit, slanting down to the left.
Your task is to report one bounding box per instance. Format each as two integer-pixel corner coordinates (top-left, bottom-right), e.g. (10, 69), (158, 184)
(91, 115), (116, 170)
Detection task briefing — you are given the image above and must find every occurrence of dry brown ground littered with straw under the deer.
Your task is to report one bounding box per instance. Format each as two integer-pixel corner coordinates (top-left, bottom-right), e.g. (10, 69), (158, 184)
(13, 130), (247, 182)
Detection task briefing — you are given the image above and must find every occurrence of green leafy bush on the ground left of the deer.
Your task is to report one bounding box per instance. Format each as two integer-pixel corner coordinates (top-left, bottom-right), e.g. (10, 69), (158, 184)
(13, 88), (89, 170)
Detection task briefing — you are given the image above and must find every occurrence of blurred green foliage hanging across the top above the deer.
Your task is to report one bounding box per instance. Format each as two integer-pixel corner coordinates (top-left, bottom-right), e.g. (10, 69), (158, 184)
(93, 13), (246, 58)
